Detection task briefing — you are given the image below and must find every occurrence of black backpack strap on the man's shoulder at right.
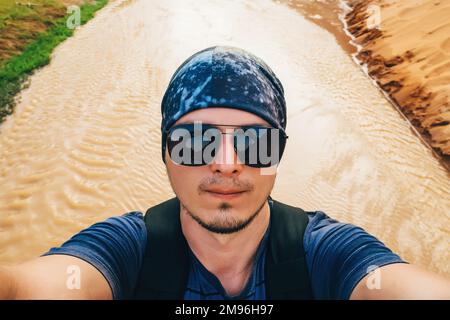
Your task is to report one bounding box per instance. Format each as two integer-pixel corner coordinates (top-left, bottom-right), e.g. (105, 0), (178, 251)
(265, 200), (313, 300)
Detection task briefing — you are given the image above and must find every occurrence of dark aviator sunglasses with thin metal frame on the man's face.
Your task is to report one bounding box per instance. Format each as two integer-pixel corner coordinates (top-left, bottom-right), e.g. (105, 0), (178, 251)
(166, 122), (288, 168)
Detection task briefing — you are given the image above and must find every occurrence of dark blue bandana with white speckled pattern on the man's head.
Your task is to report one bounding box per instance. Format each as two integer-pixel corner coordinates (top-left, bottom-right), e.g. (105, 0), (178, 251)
(161, 46), (287, 161)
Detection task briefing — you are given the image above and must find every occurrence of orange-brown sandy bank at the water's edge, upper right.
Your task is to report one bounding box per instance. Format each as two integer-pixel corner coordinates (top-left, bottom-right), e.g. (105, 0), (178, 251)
(346, 0), (450, 170)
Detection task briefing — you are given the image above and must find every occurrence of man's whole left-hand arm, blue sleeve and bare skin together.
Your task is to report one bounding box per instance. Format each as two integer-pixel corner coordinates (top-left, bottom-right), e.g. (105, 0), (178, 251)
(0, 212), (147, 299)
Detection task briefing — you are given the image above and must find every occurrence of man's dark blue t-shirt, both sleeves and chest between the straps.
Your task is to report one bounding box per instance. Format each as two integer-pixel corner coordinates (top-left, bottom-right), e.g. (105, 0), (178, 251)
(44, 200), (404, 300)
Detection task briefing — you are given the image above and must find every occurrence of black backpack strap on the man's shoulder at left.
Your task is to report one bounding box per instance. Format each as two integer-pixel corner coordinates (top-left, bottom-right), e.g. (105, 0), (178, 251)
(134, 197), (189, 300)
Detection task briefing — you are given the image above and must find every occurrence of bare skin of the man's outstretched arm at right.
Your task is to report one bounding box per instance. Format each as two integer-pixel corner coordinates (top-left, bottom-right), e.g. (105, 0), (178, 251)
(350, 263), (450, 300)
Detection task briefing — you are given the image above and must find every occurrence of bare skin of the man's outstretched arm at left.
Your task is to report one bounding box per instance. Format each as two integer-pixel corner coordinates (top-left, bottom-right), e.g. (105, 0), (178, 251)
(0, 255), (112, 299)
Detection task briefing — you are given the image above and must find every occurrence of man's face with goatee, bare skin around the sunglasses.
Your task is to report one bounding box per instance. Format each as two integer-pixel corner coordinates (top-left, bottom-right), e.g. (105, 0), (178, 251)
(165, 108), (276, 233)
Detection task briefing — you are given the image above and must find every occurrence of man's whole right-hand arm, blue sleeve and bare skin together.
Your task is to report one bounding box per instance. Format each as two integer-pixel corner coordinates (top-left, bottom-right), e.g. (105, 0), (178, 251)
(304, 211), (450, 299)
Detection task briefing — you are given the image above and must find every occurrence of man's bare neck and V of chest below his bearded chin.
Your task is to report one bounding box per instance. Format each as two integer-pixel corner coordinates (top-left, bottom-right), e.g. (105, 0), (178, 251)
(180, 201), (270, 294)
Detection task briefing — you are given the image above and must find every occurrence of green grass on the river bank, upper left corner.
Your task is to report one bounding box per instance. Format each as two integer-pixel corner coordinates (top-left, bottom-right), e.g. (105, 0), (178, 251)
(0, 0), (108, 123)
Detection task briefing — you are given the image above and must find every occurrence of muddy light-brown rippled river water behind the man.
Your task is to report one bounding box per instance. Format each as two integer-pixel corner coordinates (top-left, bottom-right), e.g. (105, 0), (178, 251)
(0, 0), (450, 274)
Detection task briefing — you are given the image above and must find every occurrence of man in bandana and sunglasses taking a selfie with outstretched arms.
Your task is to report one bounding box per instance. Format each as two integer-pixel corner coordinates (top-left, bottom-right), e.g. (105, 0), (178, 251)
(0, 47), (450, 299)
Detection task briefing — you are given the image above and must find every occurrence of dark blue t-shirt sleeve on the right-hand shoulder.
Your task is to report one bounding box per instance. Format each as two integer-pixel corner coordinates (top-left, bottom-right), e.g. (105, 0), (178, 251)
(303, 211), (403, 299)
